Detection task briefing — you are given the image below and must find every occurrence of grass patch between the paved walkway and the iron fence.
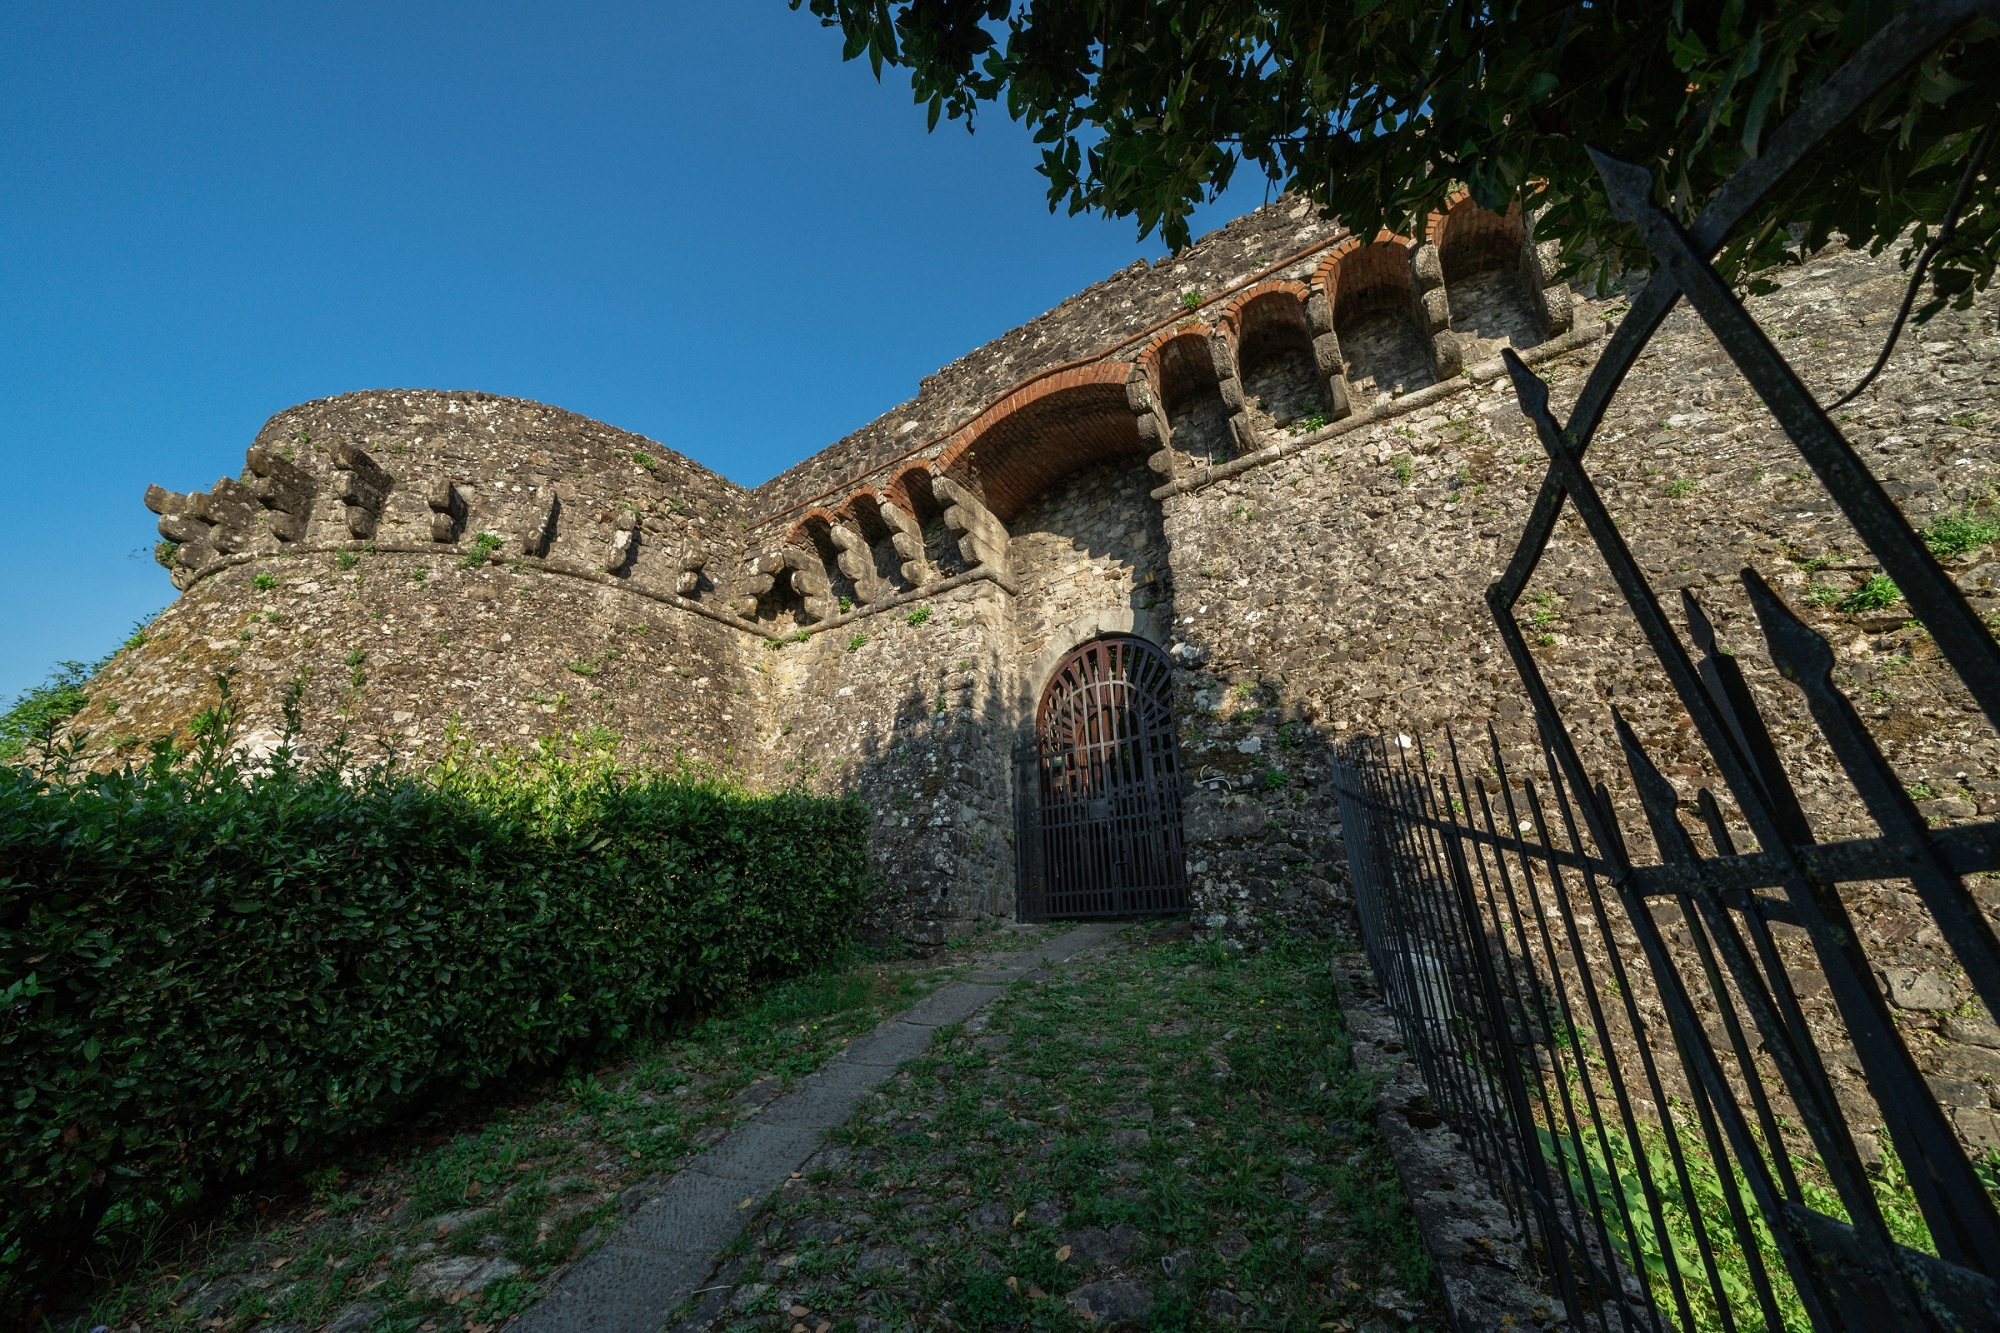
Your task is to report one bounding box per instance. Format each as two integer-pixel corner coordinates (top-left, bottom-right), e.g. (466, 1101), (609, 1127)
(704, 929), (1446, 1333)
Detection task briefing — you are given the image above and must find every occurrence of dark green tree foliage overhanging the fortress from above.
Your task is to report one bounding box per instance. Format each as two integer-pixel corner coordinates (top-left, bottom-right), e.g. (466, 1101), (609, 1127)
(792, 0), (2000, 298)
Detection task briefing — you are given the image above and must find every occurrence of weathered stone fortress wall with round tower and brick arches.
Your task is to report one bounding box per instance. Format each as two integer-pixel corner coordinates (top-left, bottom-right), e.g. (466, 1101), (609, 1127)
(78, 189), (2000, 1143)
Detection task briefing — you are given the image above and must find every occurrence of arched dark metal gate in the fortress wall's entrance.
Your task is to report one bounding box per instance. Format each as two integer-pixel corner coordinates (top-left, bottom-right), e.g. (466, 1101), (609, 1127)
(1016, 638), (1188, 921)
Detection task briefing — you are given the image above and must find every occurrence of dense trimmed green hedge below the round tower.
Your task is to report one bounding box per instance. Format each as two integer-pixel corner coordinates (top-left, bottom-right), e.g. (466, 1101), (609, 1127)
(0, 732), (868, 1297)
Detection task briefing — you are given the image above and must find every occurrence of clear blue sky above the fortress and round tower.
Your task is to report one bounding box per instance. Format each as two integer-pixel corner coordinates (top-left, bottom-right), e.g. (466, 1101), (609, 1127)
(0, 0), (1264, 703)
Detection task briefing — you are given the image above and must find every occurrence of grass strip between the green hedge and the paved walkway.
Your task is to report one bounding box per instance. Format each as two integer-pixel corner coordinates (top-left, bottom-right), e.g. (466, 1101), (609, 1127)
(46, 939), (1032, 1333)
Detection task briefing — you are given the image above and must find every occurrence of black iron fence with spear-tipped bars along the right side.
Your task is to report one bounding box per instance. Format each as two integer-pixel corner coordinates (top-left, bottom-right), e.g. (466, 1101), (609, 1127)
(1336, 0), (2000, 1331)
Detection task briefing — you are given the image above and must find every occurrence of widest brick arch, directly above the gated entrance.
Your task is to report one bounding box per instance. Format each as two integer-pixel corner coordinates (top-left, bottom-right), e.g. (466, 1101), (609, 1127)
(934, 360), (1148, 520)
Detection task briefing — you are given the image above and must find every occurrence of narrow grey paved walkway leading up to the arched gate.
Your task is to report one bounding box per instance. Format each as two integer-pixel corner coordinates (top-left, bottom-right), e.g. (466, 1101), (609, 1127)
(508, 923), (1122, 1333)
